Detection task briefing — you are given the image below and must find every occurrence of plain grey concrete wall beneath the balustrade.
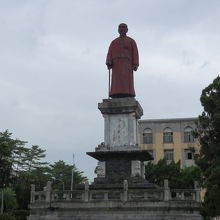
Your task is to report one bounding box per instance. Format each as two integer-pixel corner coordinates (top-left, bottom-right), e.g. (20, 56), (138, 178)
(28, 201), (202, 220)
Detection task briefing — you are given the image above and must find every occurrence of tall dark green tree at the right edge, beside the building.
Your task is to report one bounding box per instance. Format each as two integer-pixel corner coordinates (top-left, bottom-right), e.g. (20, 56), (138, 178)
(195, 76), (220, 217)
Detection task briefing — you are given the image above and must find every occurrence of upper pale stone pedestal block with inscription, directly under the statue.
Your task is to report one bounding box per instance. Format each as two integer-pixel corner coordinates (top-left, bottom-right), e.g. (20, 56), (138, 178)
(98, 98), (143, 150)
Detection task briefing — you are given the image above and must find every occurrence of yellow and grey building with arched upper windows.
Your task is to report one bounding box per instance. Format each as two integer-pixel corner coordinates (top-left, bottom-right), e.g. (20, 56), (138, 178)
(138, 118), (199, 167)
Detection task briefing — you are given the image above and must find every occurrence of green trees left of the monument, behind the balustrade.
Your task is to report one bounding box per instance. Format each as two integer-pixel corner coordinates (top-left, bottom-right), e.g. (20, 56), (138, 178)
(0, 130), (87, 220)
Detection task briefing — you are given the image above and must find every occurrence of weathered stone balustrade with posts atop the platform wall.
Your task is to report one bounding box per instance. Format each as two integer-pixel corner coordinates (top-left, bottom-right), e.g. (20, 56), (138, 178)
(31, 180), (200, 204)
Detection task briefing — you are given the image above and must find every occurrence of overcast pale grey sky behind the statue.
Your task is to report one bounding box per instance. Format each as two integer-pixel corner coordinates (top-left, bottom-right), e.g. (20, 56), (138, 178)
(0, 0), (220, 179)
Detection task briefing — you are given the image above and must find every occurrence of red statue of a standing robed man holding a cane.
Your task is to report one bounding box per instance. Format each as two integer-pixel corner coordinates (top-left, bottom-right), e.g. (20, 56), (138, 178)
(106, 23), (139, 98)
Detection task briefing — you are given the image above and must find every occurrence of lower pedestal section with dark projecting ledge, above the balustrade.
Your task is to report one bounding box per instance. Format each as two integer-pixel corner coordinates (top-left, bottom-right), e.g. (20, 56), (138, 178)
(87, 148), (152, 184)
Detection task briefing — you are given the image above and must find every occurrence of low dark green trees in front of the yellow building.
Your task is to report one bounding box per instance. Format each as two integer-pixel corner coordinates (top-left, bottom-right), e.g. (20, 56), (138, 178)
(145, 159), (201, 189)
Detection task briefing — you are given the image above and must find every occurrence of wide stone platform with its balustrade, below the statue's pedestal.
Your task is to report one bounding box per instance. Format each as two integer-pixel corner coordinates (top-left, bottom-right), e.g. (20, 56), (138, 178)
(28, 181), (202, 220)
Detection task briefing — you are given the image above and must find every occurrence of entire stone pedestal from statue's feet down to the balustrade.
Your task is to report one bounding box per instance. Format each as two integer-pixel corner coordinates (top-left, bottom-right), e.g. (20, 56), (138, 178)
(87, 98), (152, 184)
